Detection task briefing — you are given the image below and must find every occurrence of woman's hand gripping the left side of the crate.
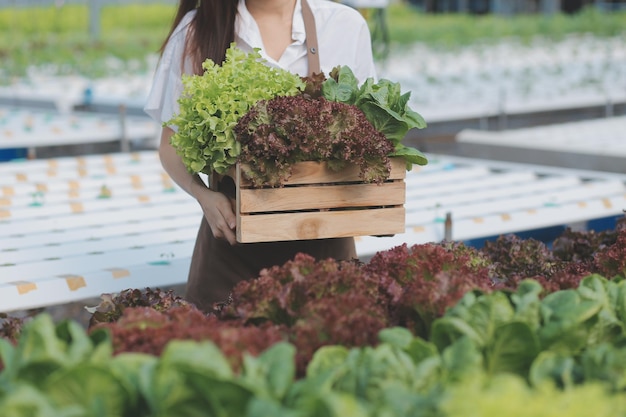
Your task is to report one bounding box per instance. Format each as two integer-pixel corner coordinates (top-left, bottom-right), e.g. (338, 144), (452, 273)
(193, 187), (237, 245)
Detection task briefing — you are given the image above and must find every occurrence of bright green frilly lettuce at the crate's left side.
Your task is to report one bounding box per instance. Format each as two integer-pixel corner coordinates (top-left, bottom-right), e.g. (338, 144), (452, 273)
(165, 44), (305, 174)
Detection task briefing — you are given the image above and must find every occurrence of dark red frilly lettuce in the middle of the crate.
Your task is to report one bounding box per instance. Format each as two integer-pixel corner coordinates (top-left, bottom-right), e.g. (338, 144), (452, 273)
(235, 95), (394, 187)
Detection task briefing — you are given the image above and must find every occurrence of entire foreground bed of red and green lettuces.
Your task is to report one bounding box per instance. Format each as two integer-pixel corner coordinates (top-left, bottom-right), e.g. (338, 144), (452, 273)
(0, 222), (626, 417)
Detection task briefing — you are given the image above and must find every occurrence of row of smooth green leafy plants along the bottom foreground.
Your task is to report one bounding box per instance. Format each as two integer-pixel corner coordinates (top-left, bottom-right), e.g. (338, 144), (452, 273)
(0, 276), (626, 417)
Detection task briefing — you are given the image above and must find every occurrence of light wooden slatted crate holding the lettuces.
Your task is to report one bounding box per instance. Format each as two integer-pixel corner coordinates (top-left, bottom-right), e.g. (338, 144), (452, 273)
(231, 158), (406, 243)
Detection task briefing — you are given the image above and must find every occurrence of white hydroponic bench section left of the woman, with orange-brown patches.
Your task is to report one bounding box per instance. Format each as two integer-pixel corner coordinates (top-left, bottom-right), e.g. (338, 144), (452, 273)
(0, 151), (201, 311)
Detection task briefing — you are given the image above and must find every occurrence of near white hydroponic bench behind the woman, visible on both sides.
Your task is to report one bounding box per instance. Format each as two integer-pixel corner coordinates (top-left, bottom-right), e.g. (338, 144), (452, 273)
(0, 151), (626, 312)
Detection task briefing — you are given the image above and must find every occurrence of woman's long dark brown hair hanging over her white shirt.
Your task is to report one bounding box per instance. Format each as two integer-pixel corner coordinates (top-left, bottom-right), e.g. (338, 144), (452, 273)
(159, 0), (239, 74)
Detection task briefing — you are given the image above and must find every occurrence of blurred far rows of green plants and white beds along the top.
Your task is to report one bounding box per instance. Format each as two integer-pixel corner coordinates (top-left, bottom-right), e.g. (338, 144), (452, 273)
(0, 0), (626, 159)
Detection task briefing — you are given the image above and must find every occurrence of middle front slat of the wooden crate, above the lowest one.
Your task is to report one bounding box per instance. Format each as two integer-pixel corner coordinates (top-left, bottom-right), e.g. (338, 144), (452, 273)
(239, 181), (405, 214)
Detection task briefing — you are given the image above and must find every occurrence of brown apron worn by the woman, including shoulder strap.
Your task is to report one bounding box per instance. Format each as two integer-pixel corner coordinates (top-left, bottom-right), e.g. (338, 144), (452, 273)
(185, 0), (356, 311)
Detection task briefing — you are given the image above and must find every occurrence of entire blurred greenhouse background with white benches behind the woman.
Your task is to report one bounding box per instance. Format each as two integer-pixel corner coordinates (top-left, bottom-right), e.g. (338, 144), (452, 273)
(0, 0), (626, 314)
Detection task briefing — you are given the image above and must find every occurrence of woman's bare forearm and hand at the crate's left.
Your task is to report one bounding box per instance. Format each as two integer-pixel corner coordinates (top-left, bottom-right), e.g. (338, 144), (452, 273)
(159, 127), (237, 245)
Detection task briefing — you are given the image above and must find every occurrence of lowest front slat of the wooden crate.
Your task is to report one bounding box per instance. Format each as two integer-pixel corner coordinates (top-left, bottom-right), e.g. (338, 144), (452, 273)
(237, 207), (404, 243)
